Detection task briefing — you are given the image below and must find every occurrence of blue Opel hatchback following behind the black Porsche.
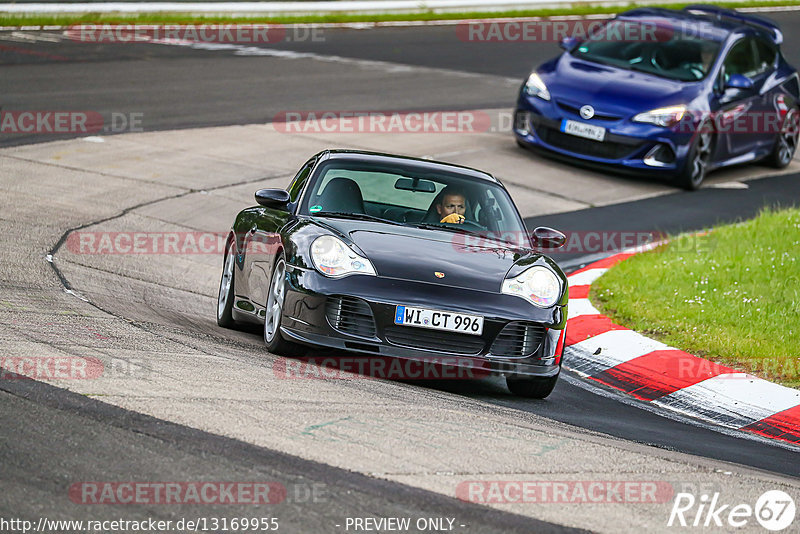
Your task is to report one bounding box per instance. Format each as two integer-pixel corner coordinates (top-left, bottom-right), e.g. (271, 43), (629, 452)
(513, 5), (800, 189)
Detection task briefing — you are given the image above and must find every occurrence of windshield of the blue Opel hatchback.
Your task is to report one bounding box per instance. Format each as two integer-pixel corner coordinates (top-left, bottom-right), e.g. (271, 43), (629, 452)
(572, 20), (720, 81)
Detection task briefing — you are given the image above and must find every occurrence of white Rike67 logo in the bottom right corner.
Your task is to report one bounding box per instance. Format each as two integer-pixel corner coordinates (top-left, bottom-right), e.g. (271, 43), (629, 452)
(667, 490), (797, 532)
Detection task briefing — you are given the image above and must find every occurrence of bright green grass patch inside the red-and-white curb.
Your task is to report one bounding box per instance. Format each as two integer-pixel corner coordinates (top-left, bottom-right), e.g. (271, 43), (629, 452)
(589, 208), (800, 388)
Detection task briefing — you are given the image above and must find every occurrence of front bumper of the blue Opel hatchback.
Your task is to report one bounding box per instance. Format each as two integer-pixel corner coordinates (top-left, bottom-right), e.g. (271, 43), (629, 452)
(513, 93), (692, 176)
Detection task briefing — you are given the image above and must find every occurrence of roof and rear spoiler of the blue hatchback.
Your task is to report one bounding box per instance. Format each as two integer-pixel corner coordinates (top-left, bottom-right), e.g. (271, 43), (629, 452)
(618, 4), (783, 44)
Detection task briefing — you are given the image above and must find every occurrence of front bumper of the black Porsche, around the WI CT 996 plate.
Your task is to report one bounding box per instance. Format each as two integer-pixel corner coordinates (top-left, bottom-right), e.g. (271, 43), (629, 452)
(281, 267), (567, 377)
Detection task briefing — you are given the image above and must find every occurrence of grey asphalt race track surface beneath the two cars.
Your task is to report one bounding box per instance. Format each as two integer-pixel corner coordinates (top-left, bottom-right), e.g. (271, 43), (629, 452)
(0, 11), (800, 532)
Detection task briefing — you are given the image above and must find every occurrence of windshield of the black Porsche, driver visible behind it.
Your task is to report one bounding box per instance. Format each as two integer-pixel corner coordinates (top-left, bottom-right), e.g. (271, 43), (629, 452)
(299, 160), (529, 247)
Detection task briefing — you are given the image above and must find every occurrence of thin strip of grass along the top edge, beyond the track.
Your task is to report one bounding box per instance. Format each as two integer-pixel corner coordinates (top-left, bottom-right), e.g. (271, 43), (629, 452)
(0, 0), (800, 26)
